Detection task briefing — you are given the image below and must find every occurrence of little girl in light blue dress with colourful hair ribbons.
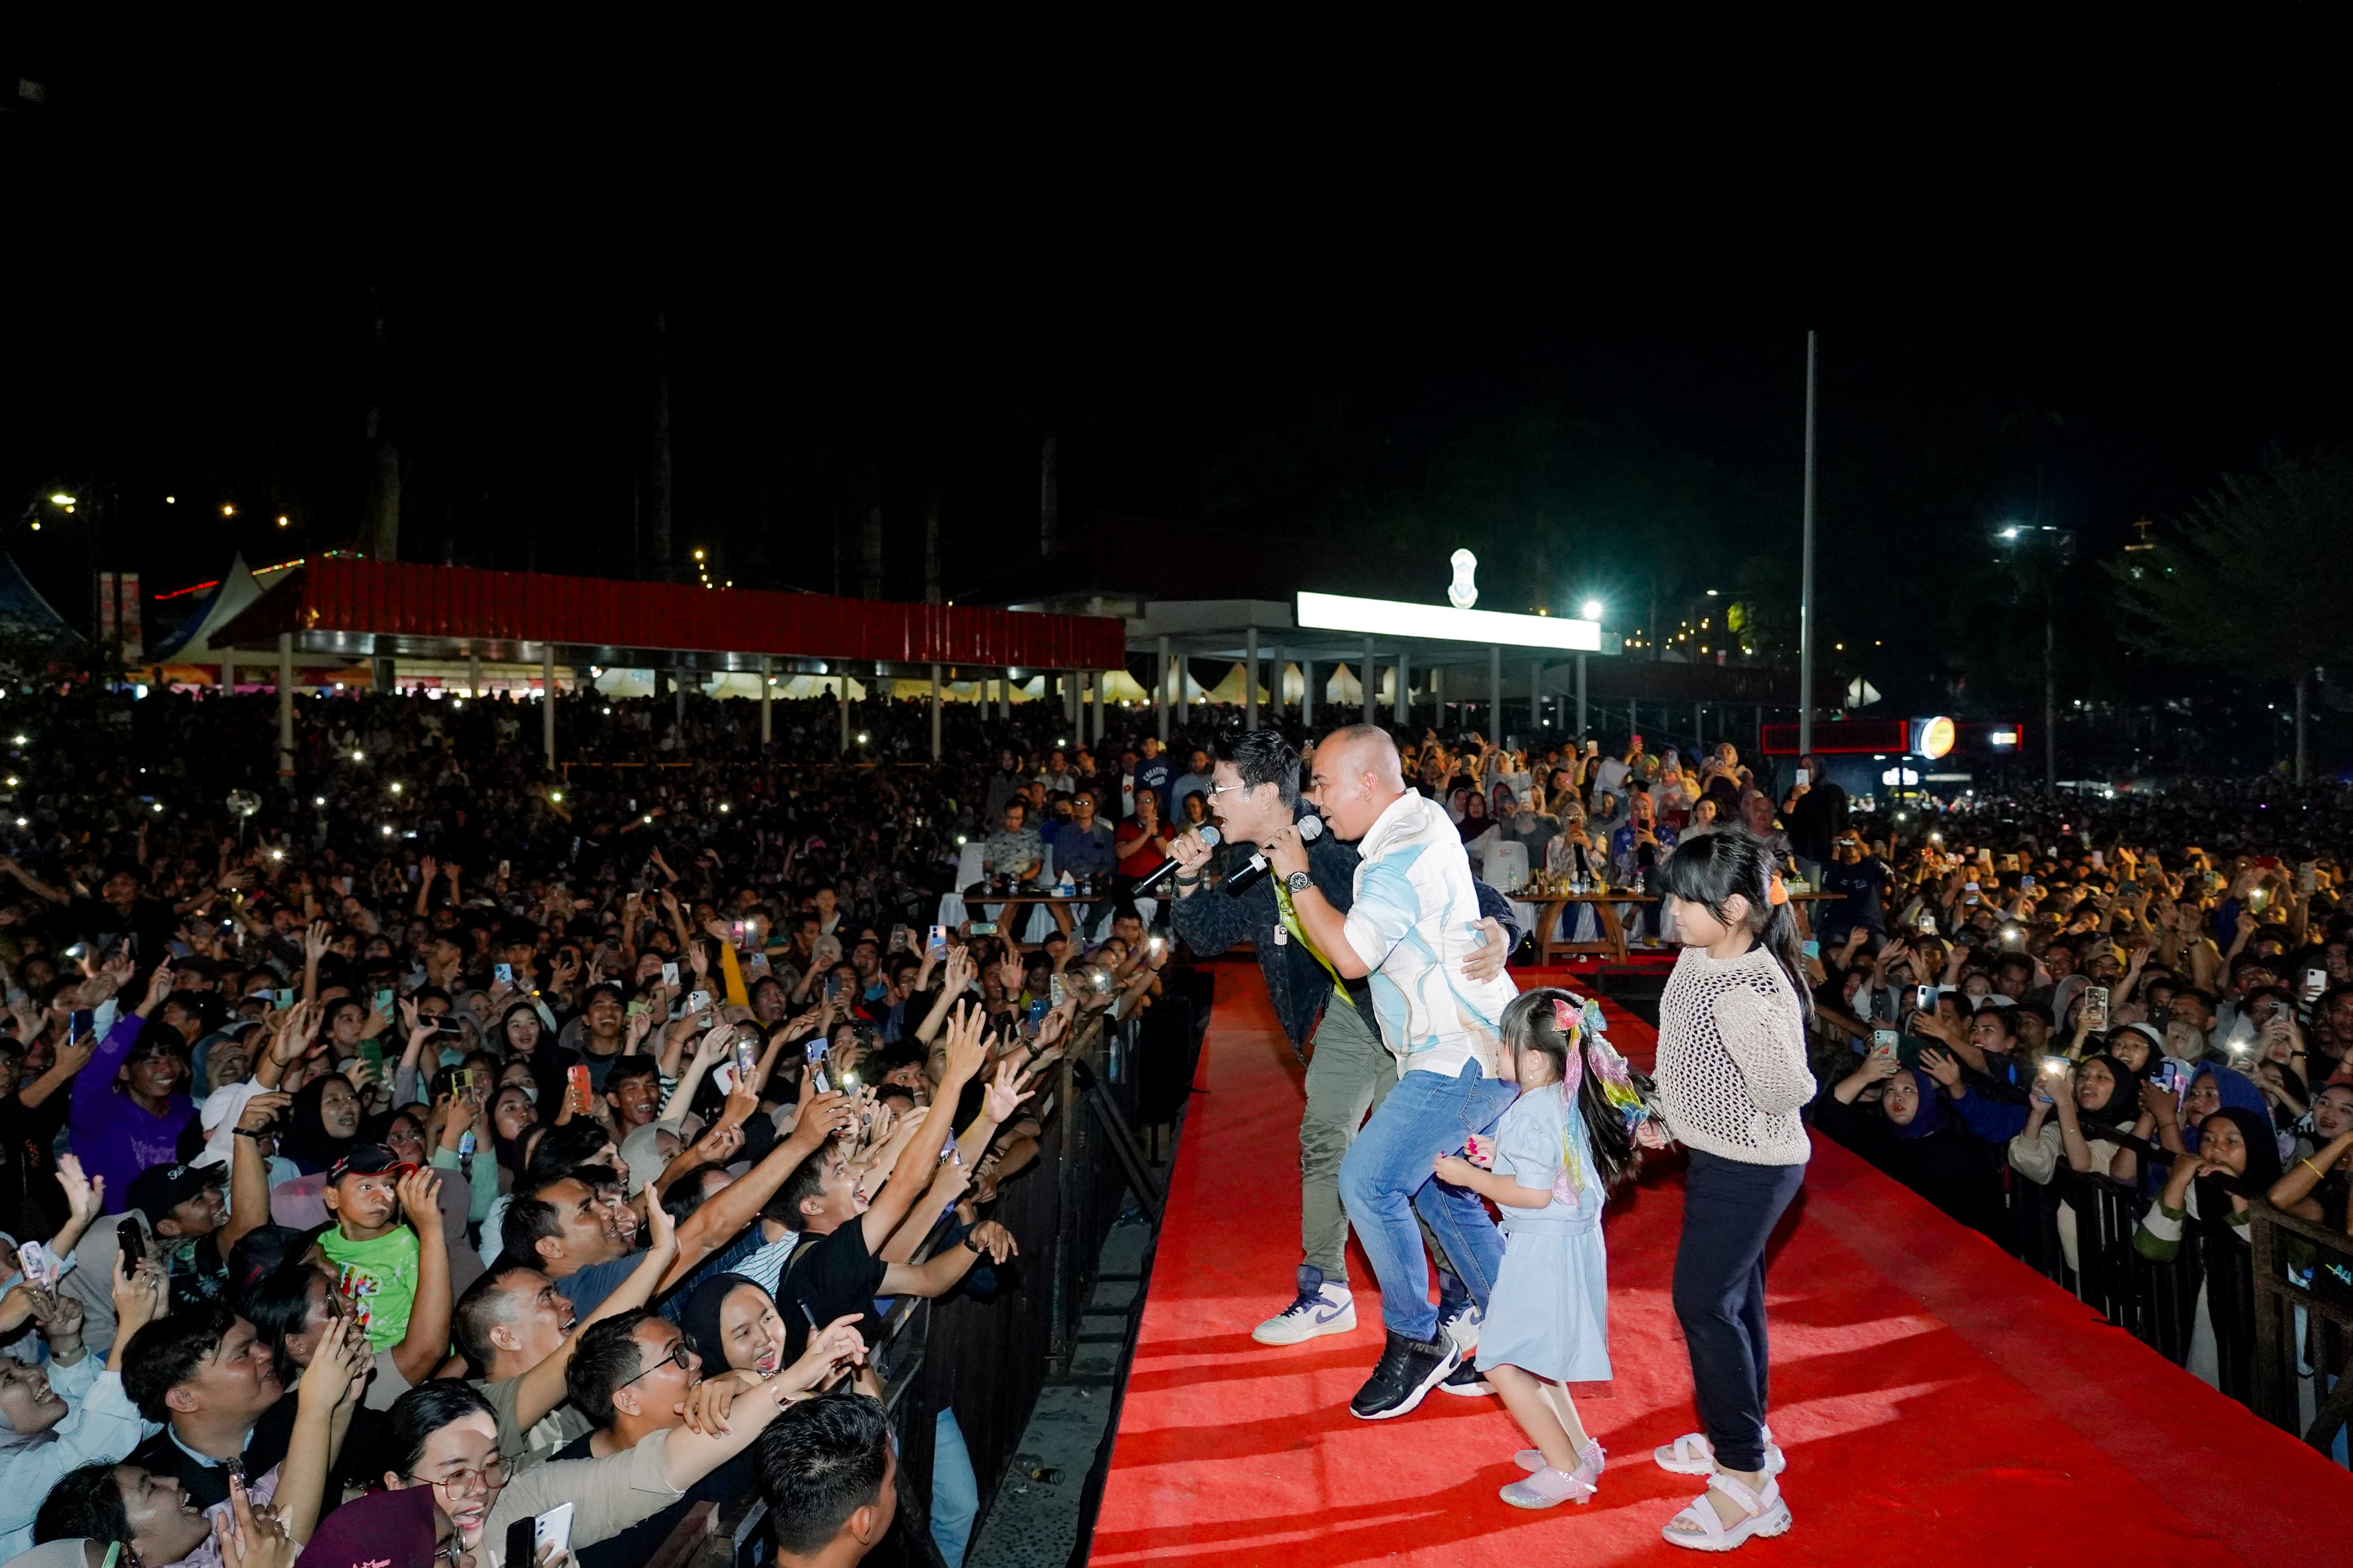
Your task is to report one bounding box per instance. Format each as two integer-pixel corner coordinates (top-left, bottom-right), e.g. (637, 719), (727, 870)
(1438, 987), (1645, 1509)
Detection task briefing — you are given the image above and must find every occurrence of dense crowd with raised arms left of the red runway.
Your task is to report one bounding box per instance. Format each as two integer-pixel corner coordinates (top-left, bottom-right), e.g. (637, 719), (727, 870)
(0, 693), (1214, 1568)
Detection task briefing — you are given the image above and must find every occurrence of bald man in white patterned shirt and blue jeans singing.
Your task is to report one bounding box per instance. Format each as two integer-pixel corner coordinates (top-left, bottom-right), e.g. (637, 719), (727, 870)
(1261, 724), (1518, 1420)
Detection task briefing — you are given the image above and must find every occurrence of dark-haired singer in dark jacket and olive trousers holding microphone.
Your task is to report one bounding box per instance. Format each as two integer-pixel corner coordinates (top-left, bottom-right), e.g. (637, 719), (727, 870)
(1170, 729), (1520, 1399)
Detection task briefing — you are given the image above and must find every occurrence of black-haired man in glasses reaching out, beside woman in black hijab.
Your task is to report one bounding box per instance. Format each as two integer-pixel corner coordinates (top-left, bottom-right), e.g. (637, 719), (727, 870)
(550, 1307), (866, 1568)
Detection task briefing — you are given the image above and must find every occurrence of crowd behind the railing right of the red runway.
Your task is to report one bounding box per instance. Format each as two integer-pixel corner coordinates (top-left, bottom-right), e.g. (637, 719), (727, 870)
(1783, 762), (2353, 1444)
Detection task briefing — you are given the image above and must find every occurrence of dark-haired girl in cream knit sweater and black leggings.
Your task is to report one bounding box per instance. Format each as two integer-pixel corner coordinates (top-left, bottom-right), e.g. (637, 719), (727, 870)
(1654, 827), (1814, 1552)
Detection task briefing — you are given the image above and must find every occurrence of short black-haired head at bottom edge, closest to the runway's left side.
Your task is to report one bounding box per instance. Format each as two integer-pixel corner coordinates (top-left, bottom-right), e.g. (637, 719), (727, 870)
(760, 1394), (899, 1568)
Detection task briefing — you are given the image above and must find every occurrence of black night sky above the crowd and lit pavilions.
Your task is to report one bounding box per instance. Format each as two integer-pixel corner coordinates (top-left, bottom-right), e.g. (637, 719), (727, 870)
(0, 35), (2353, 728)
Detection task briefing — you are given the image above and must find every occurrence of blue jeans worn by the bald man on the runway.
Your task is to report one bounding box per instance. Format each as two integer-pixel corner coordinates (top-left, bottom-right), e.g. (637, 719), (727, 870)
(1339, 1062), (1518, 1340)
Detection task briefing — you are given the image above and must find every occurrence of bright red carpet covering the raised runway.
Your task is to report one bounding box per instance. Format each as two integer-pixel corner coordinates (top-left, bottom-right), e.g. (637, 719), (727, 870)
(1092, 964), (2353, 1568)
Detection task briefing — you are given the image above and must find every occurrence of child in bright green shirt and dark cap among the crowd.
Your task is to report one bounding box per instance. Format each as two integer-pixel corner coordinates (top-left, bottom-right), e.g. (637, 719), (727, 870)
(318, 1143), (450, 1349)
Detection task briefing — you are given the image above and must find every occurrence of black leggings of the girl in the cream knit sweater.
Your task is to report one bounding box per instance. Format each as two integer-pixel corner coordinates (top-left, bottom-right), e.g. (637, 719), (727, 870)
(1675, 1150), (1805, 1472)
